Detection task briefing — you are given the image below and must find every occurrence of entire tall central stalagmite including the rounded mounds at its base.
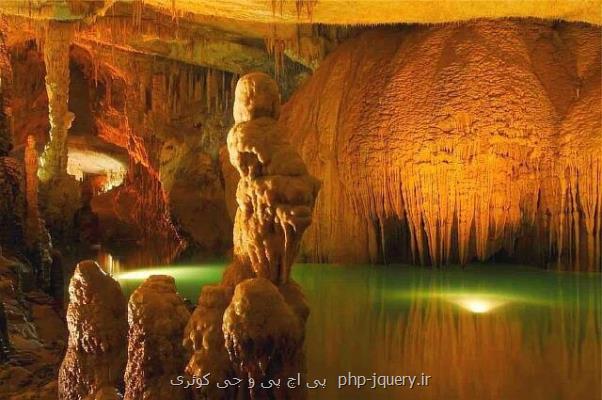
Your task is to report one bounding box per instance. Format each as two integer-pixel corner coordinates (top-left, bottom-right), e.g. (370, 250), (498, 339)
(184, 73), (320, 399)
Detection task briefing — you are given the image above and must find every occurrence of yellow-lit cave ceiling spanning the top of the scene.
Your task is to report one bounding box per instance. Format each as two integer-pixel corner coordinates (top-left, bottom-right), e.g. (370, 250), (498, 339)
(0, 0), (602, 81)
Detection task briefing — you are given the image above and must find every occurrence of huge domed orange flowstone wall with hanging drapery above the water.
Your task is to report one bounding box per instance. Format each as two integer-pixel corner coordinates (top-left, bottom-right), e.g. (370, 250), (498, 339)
(280, 21), (602, 269)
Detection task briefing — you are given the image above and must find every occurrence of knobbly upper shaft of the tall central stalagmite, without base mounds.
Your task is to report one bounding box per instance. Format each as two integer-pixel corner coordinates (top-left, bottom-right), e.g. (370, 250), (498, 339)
(228, 73), (320, 285)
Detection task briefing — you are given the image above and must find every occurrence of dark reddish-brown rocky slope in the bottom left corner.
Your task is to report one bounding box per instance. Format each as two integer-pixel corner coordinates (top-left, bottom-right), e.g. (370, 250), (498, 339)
(0, 248), (66, 400)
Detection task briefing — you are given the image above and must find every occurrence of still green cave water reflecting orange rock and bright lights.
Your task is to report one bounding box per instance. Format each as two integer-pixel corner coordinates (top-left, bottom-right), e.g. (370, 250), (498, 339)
(111, 263), (602, 400)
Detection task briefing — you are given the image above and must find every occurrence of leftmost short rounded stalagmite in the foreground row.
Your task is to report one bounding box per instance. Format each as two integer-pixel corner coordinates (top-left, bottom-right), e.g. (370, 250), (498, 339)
(58, 261), (127, 400)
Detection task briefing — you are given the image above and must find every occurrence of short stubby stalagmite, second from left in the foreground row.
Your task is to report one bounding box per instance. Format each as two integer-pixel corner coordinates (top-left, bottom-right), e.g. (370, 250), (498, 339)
(124, 275), (190, 400)
